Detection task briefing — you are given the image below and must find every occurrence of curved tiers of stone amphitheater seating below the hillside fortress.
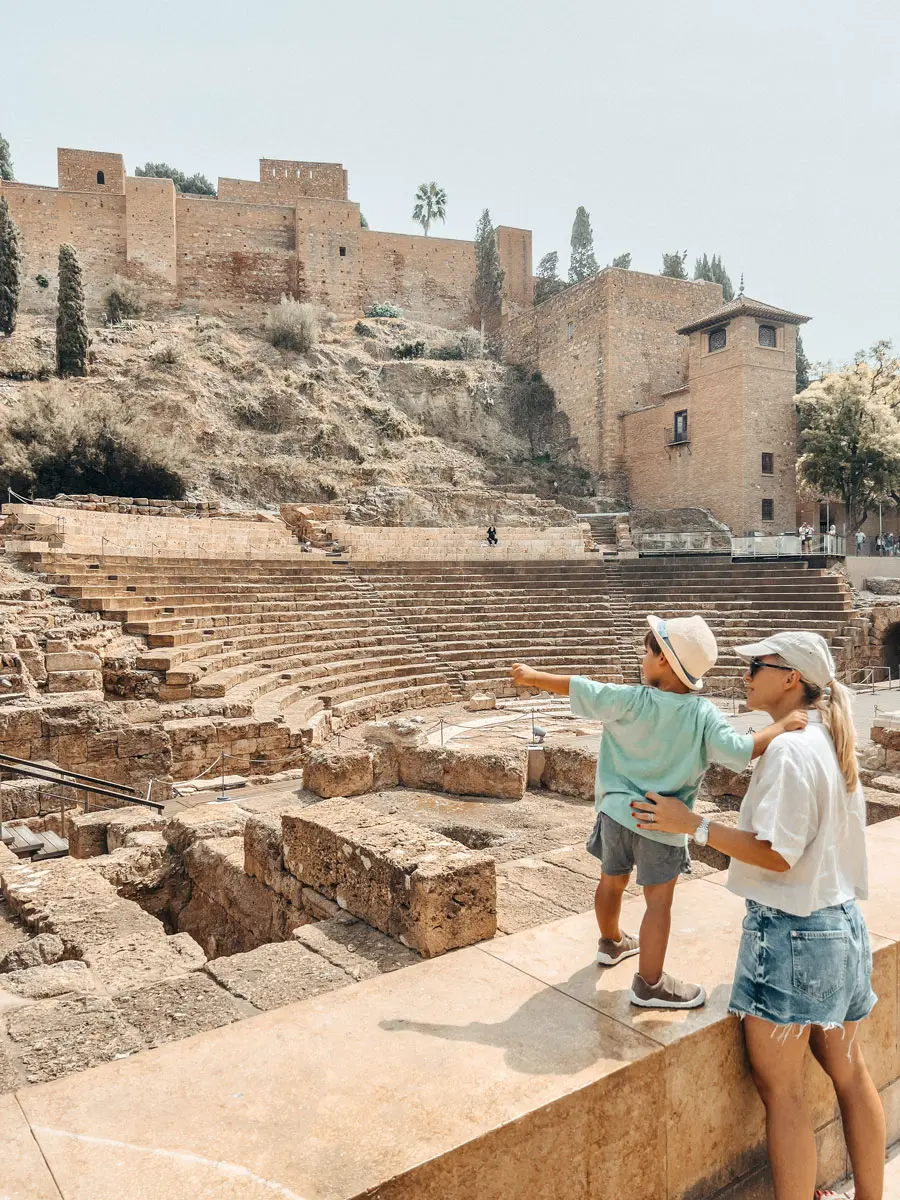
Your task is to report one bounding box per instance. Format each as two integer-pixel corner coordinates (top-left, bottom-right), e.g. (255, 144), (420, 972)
(19, 550), (850, 730)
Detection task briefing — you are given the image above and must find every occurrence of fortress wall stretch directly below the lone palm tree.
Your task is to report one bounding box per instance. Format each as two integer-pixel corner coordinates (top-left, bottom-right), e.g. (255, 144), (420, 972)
(360, 229), (476, 329)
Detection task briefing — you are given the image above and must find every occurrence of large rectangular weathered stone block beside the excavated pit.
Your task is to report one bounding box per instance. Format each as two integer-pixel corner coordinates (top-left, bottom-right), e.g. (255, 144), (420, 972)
(282, 796), (497, 958)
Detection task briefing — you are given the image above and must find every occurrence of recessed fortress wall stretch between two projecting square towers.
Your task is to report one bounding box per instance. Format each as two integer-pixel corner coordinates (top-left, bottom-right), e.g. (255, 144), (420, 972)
(175, 194), (296, 304)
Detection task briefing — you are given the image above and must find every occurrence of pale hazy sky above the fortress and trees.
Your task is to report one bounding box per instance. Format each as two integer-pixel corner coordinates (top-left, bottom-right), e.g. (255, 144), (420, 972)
(0, 0), (900, 362)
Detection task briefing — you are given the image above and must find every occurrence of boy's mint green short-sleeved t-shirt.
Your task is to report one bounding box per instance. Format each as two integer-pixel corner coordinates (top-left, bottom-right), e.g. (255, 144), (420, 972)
(569, 676), (754, 846)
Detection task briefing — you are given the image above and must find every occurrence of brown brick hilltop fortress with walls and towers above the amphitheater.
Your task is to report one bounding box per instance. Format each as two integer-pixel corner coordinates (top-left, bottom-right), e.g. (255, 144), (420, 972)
(0, 142), (809, 534)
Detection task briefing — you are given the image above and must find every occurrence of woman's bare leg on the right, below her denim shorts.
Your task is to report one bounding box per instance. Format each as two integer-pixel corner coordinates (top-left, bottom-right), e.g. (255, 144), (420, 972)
(809, 1021), (887, 1200)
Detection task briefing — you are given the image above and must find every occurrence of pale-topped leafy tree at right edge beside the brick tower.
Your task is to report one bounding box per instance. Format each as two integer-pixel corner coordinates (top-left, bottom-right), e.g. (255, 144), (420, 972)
(797, 342), (900, 533)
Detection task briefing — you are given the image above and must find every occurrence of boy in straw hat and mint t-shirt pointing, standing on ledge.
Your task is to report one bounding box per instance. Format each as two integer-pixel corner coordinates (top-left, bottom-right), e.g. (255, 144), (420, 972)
(511, 614), (806, 1008)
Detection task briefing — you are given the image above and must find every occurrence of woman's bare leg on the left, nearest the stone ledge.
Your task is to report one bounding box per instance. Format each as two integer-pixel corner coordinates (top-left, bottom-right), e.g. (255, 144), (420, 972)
(744, 1016), (816, 1200)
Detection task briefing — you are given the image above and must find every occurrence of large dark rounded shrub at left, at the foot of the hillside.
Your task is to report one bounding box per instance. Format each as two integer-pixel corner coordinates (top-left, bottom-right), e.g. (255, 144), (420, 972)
(0, 389), (185, 499)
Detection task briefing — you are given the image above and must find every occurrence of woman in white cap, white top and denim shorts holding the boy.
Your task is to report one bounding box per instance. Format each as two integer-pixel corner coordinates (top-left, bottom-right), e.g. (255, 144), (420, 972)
(634, 632), (886, 1200)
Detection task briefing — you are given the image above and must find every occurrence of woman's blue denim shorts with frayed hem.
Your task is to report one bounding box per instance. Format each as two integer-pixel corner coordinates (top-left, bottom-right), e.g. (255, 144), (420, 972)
(728, 900), (877, 1028)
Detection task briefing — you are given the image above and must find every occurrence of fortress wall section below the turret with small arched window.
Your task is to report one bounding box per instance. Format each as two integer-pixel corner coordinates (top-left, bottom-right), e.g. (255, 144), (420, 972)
(56, 192), (127, 308)
